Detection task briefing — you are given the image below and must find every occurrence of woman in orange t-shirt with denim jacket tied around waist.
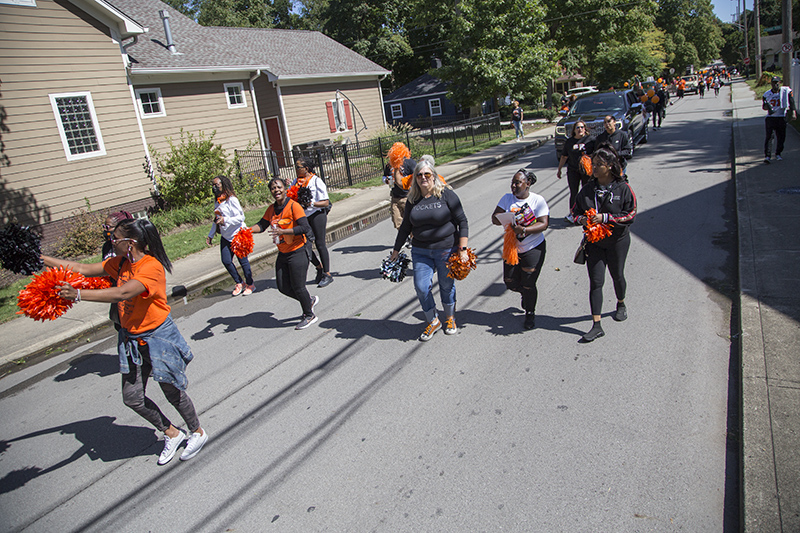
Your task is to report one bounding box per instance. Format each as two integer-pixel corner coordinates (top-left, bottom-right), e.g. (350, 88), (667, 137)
(42, 219), (208, 465)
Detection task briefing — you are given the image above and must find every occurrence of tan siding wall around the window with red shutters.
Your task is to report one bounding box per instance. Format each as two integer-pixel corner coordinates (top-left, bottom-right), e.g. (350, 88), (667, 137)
(281, 80), (383, 145)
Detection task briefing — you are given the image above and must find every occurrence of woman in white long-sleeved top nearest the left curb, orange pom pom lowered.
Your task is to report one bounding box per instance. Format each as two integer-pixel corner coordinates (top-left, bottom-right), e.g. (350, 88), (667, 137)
(206, 175), (256, 296)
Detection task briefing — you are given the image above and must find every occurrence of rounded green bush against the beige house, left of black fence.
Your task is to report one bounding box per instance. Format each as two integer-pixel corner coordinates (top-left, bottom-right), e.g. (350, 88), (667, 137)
(150, 128), (231, 208)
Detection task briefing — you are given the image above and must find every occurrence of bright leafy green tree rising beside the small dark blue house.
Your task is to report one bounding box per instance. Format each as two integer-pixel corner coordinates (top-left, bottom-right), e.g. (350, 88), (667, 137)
(436, 0), (555, 106)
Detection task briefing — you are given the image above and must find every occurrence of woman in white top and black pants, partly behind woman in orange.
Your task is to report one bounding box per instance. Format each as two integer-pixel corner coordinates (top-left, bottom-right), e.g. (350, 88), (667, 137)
(294, 157), (333, 288)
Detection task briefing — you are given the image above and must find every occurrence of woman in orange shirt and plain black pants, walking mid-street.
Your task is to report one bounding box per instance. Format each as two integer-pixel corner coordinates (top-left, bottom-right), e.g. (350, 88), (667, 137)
(250, 178), (319, 329)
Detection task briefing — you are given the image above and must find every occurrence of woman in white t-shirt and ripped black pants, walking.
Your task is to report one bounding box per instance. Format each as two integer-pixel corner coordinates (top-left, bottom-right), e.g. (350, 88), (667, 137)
(492, 168), (550, 329)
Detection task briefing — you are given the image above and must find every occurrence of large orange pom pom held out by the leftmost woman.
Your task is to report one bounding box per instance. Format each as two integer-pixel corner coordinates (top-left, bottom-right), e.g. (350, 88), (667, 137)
(17, 267), (84, 322)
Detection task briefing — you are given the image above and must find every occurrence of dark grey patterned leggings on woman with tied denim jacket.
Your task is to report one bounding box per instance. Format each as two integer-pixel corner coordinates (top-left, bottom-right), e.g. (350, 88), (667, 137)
(122, 345), (200, 433)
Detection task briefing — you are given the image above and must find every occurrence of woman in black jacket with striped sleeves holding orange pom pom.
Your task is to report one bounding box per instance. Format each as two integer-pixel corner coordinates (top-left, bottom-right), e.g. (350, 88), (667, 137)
(572, 144), (636, 342)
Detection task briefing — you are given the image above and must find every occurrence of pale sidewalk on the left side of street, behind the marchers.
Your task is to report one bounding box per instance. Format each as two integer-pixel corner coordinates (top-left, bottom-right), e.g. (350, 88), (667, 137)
(0, 126), (555, 366)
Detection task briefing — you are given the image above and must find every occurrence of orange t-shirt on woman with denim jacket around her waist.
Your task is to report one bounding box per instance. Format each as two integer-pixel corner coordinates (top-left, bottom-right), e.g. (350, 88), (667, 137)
(103, 255), (170, 334)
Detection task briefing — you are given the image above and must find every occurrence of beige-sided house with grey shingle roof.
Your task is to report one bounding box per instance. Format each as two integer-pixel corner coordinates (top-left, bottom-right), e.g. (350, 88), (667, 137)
(0, 0), (389, 244)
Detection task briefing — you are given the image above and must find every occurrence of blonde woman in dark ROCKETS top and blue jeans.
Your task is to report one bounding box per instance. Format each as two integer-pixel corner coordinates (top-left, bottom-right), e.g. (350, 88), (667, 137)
(390, 155), (469, 342)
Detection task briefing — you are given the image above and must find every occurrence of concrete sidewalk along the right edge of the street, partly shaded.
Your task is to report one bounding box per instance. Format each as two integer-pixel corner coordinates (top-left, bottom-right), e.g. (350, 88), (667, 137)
(732, 80), (800, 533)
